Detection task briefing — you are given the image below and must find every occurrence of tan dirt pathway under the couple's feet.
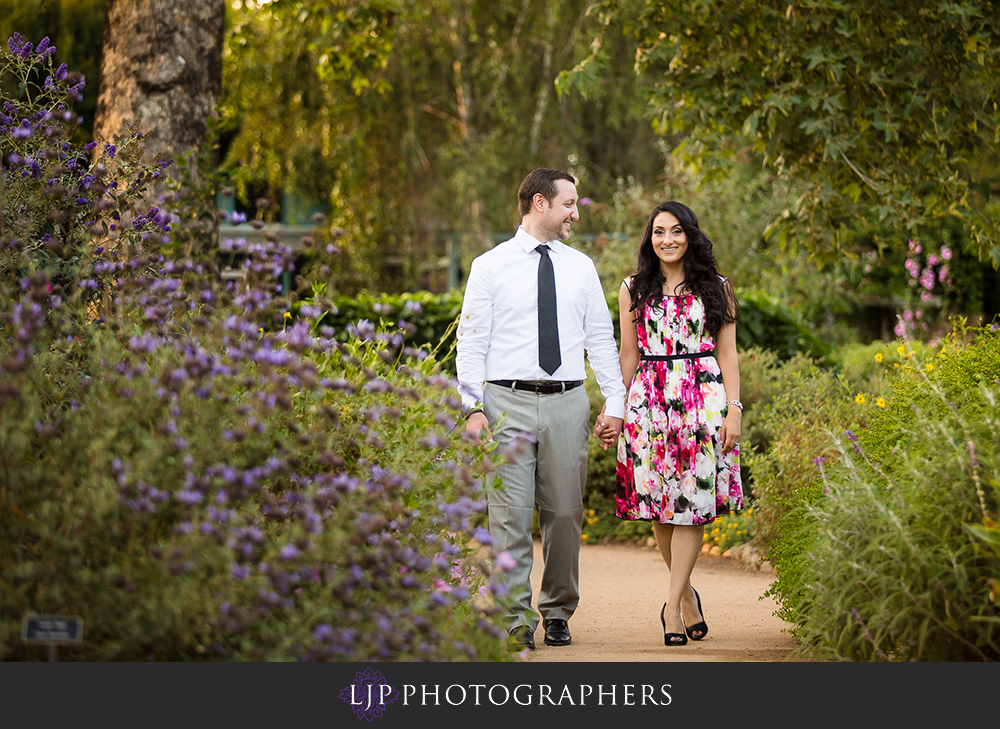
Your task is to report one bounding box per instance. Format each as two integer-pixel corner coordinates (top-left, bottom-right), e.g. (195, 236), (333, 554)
(526, 540), (796, 662)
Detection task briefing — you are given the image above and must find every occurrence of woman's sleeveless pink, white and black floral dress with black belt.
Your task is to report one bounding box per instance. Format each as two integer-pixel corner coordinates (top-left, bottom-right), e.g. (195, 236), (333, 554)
(615, 282), (743, 525)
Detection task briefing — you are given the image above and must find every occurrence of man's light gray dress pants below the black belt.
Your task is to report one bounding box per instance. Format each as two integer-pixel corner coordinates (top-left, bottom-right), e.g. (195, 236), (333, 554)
(483, 383), (590, 631)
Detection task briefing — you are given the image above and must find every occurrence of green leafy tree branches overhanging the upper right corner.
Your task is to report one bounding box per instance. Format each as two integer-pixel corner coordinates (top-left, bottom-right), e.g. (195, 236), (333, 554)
(566, 0), (1000, 263)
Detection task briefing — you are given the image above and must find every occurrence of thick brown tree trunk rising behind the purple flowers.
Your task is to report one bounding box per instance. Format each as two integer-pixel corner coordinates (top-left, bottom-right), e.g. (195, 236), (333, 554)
(94, 0), (226, 181)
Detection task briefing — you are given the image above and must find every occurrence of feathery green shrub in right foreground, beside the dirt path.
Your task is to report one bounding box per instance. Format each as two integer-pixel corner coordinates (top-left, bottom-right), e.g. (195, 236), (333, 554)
(782, 331), (1000, 661)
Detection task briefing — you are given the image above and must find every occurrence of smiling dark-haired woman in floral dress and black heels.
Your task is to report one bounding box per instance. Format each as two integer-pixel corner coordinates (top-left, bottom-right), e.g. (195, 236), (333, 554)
(595, 202), (743, 646)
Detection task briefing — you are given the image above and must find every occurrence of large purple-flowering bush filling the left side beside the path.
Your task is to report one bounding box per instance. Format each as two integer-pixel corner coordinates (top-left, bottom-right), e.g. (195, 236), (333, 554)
(0, 36), (508, 661)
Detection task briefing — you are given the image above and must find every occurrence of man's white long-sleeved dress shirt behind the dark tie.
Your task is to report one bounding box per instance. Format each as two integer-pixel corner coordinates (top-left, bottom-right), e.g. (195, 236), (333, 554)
(456, 227), (625, 418)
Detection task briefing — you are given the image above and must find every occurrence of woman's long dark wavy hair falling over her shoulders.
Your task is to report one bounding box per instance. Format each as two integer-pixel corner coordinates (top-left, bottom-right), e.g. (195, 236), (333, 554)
(629, 201), (739, 337)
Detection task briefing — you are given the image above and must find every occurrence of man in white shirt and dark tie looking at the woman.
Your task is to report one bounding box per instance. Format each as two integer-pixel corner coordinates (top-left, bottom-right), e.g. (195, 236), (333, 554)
(456, 169), (625, 650)
